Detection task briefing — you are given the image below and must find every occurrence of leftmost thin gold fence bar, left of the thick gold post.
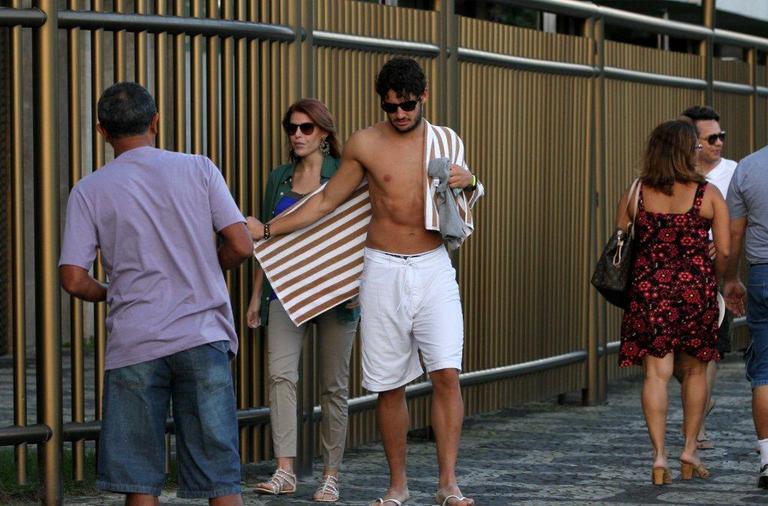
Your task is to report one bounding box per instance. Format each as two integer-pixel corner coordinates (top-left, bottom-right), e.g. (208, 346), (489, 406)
(10, 0), (27, 485)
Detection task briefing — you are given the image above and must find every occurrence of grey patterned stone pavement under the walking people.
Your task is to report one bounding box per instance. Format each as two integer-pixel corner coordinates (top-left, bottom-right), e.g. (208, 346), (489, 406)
(10, 356), (768, 506)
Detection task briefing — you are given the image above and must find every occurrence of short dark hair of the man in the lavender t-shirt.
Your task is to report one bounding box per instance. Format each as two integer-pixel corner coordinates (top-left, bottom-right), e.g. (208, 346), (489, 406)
(98, 82), (157, 139)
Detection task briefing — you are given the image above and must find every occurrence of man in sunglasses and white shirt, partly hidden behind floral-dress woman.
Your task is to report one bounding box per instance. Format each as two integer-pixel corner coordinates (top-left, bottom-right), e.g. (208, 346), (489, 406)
(675, 105), (736, 450)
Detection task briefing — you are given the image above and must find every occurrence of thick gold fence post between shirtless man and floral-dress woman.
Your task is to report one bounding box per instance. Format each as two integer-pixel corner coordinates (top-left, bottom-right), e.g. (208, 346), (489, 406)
(583, 13), (607, 405)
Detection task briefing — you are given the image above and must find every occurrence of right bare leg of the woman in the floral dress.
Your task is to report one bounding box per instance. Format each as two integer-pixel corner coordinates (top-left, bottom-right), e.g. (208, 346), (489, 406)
(680, 353), (708, 464)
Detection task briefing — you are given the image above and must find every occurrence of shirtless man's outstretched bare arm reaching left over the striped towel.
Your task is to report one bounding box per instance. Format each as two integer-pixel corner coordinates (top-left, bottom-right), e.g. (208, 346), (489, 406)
(248, 135), (365, 239)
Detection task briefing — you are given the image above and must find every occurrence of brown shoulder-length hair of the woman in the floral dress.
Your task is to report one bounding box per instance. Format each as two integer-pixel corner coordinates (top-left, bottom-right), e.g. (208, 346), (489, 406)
(640, 119), (704, 195)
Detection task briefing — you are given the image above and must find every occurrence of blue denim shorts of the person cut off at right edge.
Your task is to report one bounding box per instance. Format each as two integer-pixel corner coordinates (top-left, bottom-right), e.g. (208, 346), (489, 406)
(744, 264), (768, 388)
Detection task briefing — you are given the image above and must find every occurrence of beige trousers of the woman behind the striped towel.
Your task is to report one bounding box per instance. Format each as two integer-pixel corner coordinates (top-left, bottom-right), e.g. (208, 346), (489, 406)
(267, 300), (357, 469)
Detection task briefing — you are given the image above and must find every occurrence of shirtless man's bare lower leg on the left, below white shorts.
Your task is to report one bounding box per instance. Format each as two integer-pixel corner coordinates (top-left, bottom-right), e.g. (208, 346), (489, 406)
(370, 386), (409, 504)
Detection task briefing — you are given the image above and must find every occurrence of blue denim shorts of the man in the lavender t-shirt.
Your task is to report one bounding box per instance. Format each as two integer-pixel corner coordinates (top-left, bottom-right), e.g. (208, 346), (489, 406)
(96, 341), (240, 498)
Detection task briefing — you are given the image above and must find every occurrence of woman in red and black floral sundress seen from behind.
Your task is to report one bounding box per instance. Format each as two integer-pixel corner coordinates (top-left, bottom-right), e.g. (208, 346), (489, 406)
(616, 120), (730, 485)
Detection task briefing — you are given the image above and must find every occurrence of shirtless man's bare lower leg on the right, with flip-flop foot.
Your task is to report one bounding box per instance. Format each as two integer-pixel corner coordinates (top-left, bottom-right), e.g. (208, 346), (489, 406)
(429, 369), (475, 506)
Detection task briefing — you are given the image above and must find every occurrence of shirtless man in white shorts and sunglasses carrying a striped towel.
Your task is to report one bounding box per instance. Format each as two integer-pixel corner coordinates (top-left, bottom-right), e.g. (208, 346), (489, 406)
(248, 58), (476, 506)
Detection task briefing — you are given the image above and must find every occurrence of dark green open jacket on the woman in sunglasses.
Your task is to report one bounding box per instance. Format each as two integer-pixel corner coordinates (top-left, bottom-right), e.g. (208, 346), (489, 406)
(260, 156), (360, 326)
